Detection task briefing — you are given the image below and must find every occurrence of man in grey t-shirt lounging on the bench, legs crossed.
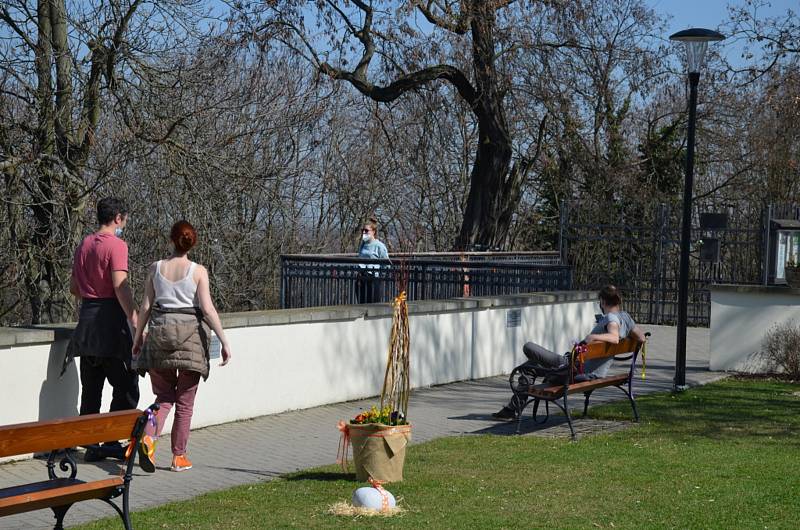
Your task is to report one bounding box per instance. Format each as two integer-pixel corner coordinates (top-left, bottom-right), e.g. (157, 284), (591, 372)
(492, 285), (646, 420)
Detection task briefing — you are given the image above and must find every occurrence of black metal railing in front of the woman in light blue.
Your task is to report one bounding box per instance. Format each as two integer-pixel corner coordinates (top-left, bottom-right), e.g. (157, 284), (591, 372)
(281, 252), (572, 309)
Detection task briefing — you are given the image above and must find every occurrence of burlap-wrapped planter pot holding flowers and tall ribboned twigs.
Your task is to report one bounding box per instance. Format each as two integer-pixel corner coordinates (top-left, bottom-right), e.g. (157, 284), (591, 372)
(347, 423), (411, 482)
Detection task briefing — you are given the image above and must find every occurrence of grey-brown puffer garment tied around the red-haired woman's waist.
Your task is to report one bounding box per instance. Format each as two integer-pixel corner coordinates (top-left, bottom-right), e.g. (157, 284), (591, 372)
(135, 305), (211, 380)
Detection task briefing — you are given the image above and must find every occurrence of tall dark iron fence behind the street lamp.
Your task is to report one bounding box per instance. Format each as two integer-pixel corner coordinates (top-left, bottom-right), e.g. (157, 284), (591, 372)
(561, 205), (800, 326)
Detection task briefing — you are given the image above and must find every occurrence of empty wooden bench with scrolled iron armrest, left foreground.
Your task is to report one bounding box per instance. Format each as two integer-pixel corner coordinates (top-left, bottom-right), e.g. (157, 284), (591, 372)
(0, 405), (158, 529)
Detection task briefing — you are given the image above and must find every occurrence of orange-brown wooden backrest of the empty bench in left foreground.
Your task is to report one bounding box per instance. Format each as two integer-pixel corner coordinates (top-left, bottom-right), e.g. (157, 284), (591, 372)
(0, 409), (142, 457)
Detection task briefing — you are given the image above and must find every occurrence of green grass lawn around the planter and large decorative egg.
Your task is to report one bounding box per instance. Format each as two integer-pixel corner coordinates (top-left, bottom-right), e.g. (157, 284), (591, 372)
(80, 379), (800, 530)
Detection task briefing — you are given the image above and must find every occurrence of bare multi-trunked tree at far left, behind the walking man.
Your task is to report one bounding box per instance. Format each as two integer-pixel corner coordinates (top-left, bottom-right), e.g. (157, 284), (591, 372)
(0, 0), (212, 323)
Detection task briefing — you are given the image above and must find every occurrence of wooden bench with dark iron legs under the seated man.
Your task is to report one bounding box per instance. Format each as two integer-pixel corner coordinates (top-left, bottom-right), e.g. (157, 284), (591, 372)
(511, 333), (650, 440)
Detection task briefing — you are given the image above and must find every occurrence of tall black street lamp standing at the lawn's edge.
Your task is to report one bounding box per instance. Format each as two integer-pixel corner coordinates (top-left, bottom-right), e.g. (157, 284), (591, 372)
(669, 28), (725, 392)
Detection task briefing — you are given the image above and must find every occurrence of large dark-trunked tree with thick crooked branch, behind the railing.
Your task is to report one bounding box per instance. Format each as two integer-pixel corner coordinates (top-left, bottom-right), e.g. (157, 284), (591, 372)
(241, 0), (564, 248)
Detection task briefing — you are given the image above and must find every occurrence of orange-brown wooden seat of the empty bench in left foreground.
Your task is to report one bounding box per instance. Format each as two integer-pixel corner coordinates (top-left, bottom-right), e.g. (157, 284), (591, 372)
(0, 477), (124, 517)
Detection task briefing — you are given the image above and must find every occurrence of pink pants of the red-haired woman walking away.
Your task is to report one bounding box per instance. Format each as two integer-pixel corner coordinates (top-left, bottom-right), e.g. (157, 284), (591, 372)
(145, 370), (200, 455)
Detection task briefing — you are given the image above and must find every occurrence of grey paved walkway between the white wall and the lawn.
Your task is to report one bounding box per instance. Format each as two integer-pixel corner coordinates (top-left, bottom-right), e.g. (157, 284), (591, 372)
(0, 326), (723, 530)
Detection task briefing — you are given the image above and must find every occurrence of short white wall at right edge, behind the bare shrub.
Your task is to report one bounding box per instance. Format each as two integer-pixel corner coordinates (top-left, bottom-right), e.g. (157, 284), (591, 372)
(709, 286), (800, 373)
